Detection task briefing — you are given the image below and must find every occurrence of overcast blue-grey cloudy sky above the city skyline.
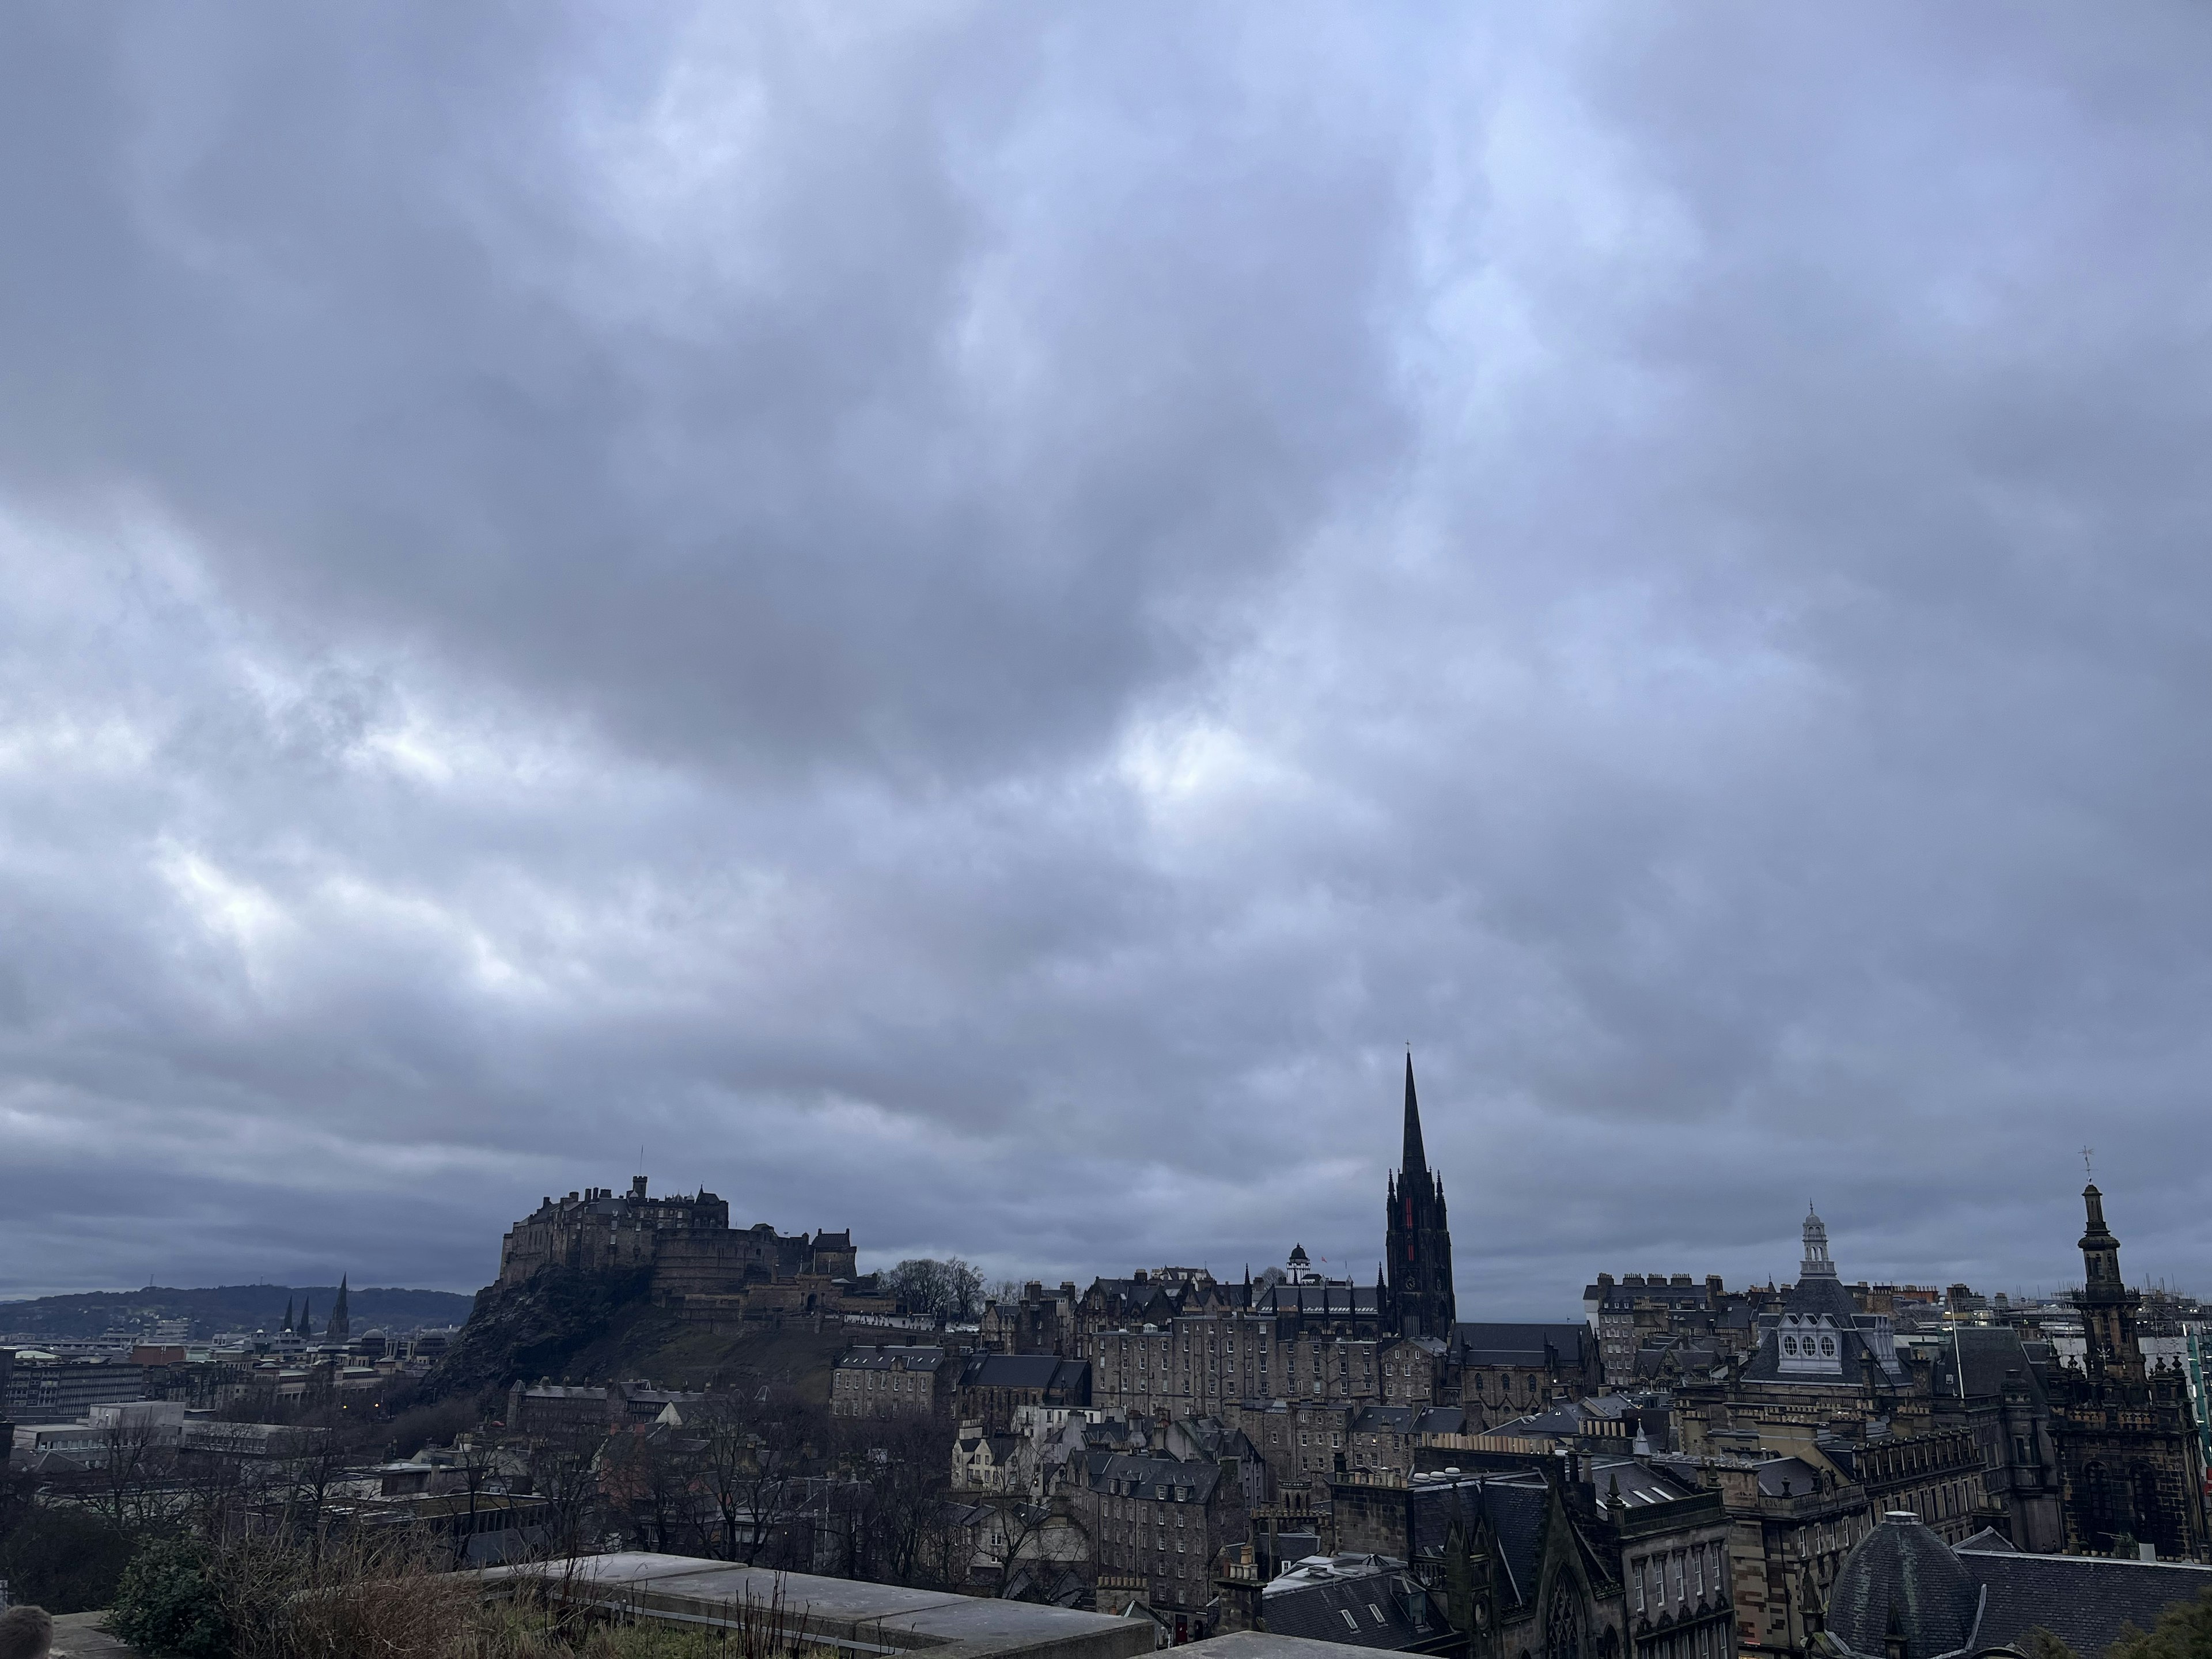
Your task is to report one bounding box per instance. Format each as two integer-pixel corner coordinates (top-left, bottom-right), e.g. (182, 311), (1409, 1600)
(0, 0), (2212, 1319)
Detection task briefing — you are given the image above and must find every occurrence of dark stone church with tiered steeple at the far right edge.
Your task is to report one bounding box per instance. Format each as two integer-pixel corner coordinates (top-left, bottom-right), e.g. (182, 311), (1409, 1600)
(2048, 1183), (2205, 1562)
